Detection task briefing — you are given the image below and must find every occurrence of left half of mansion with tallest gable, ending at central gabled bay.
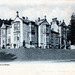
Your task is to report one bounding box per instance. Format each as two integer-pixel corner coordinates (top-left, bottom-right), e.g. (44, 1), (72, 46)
(1, 11), (38, 48)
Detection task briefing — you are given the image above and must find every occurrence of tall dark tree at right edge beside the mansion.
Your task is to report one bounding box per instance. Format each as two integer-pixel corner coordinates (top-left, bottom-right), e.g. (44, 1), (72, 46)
(67, 13), (75, 45)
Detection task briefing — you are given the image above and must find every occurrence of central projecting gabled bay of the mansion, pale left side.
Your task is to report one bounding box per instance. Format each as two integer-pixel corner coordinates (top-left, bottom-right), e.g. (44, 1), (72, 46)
(37, 17), (51, 48)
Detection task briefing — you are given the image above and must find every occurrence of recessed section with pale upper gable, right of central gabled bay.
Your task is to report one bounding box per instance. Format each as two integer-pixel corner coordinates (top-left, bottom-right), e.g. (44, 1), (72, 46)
(51, 18), (60, 49)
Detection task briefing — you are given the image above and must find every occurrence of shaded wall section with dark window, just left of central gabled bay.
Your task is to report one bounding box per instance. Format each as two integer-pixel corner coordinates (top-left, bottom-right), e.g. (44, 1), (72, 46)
(29, 21), (38, 47)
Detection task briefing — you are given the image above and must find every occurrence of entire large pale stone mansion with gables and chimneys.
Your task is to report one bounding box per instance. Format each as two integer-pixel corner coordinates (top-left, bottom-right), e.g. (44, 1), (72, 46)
(0, 11), (68, 49)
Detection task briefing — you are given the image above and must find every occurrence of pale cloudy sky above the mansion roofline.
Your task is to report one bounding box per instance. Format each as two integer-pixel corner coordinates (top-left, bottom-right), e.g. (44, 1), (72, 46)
(0, 0), (75, 25)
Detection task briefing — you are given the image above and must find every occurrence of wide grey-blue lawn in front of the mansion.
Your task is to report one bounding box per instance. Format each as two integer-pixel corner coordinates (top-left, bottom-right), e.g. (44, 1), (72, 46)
(0, 48), (75, 62)
